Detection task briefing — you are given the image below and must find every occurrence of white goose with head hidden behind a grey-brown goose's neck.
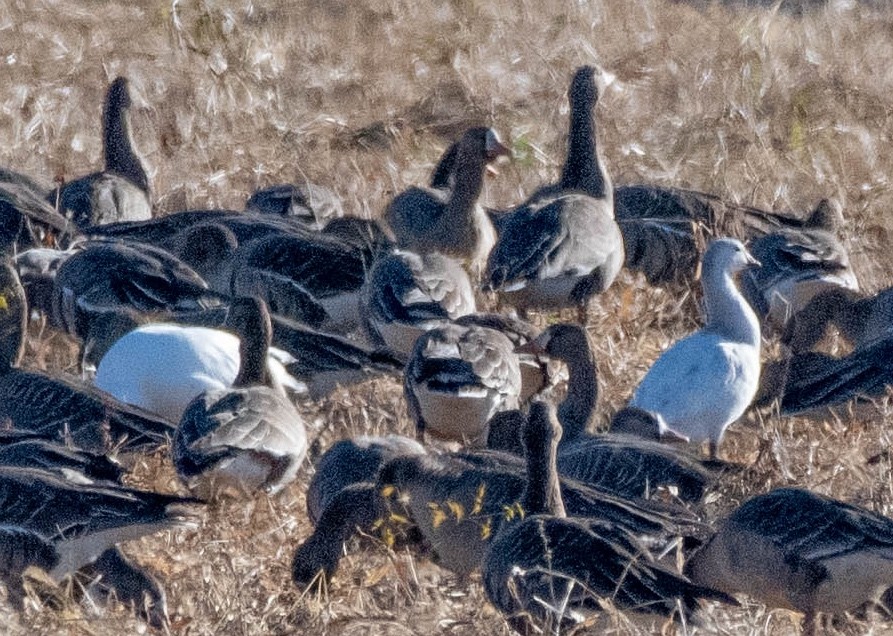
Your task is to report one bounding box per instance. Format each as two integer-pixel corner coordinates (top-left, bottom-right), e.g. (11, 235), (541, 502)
(95, 304), (305, 422)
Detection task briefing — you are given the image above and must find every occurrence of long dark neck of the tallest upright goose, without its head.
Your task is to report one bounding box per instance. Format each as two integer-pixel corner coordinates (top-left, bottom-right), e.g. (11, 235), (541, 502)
(561, 101), (611, 199)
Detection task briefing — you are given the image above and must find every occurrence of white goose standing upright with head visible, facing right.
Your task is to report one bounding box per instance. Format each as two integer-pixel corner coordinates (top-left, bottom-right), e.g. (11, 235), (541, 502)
(630, 239), (760, 456)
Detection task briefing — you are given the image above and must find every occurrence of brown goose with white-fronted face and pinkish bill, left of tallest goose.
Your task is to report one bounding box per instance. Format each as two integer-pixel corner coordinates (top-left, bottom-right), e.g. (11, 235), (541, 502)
(384, 128), (509, 272)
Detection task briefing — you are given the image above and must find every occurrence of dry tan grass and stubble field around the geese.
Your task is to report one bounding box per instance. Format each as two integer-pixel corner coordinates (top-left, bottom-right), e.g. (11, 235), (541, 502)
(0, 0), (893, 636)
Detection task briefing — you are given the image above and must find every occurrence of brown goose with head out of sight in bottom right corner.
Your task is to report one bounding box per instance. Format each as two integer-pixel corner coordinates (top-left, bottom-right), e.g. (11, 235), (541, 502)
(685, 488), (893, 634)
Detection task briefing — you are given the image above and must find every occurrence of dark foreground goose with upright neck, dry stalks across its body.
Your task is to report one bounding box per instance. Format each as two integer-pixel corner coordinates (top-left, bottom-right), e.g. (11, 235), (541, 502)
(482, 400), (735, 633)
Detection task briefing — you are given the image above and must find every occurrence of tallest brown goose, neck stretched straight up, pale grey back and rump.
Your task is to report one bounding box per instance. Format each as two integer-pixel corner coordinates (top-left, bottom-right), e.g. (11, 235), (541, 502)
(484, 66), (623, 322)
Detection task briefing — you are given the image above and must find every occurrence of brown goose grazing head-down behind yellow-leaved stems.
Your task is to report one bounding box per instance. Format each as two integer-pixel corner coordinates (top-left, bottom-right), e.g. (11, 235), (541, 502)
(292, 432), (700, 586)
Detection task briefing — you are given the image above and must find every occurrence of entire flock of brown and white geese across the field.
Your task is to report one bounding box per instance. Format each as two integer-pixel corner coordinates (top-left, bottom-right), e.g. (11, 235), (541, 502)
(0, 66), (893, 633)
